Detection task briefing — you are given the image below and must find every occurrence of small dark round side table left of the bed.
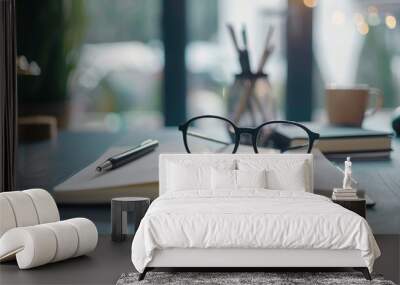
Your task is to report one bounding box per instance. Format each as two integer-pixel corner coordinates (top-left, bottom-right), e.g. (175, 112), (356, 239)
(111, 197), (150, 241)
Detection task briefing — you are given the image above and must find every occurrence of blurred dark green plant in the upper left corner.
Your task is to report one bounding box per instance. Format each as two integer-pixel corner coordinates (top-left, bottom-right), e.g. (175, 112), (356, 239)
(16, 0), (86, 103)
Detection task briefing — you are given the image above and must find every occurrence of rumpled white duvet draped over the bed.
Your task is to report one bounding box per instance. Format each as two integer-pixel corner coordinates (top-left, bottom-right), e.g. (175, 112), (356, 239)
(132, 189), (380, 272)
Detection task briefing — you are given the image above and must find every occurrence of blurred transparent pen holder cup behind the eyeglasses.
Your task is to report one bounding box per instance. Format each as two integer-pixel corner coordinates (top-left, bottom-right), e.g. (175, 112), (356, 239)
(227, 73), (276, 143)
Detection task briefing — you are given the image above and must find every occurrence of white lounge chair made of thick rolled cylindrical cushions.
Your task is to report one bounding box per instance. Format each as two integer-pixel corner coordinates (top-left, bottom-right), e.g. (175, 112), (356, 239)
(0, 189), (98, 269)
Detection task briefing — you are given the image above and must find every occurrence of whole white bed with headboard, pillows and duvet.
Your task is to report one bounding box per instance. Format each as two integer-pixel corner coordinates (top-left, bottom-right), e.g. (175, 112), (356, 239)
(132, 154), (380, 279)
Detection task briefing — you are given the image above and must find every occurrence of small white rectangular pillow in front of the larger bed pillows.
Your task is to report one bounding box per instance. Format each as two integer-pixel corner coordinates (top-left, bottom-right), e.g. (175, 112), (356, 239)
(211, 168), (267, 191)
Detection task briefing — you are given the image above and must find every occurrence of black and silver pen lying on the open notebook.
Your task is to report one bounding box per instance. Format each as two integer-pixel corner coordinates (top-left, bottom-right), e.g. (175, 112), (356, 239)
(96, 140), (158, 172)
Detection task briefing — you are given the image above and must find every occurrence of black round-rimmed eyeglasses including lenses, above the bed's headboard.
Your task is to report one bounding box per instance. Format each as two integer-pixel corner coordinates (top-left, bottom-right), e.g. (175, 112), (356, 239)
(179, 115), (319, 153)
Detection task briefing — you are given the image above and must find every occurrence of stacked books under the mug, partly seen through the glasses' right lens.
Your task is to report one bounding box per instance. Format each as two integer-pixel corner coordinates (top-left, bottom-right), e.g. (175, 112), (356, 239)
(276, 123), (393, 159)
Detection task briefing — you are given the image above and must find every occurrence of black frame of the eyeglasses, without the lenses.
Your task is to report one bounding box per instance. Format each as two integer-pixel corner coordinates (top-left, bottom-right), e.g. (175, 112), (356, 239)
(178, 115), (319, 153)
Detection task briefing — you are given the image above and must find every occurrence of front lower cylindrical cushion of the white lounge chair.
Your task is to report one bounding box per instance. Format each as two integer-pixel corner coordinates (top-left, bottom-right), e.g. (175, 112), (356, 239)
(0, 218), (98, 269)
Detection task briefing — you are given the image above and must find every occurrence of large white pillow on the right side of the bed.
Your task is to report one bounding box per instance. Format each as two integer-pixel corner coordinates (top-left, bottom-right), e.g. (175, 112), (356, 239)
(237, 159), (310, 192)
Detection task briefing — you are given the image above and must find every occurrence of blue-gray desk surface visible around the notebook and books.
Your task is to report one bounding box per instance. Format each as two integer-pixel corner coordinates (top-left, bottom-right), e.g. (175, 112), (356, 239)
(17, 115), (400, 234)
